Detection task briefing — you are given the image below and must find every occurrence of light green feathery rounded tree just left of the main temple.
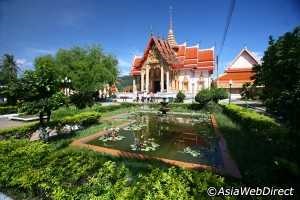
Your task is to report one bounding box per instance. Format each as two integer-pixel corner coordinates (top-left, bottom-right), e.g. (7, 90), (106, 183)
(56, 46), (118, 108)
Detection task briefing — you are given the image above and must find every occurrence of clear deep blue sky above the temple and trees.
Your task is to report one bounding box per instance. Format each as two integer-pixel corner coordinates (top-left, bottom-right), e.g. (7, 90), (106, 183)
(0, 0), (300, 75)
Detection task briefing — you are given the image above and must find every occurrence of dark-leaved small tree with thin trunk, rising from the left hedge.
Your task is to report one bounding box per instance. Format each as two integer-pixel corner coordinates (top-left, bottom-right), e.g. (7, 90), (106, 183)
(19, 55), (65, 125)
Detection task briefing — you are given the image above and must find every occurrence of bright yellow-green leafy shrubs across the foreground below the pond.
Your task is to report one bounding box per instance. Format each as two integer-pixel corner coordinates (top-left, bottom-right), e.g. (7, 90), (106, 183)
(0, 140), (230, 200)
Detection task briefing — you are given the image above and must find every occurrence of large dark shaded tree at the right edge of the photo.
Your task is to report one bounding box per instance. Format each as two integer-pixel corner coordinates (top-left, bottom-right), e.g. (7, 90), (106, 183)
(254, 27), (300, 132)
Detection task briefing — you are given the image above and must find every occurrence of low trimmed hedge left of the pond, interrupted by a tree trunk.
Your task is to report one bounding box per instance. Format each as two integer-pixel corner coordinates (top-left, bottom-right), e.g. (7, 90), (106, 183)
(0, 112), (101, 139)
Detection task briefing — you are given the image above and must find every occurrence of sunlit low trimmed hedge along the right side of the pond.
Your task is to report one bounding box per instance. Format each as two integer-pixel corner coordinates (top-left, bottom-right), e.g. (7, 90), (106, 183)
(223, 104), (279, 131)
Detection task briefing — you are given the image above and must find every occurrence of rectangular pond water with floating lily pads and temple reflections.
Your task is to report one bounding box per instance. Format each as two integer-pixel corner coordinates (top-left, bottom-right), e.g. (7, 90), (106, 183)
(90, 113), (222, 168)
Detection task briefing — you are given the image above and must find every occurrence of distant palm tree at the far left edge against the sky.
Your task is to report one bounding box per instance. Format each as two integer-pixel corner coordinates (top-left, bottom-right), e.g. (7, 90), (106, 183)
(0, 54), (19, 85)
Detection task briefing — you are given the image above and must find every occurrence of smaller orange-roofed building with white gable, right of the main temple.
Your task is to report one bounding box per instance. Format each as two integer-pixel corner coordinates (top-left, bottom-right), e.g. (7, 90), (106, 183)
(216, 48), (260, 97)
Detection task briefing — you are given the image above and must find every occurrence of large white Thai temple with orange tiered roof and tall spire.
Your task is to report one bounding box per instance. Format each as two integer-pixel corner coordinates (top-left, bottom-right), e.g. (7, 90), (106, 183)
(131, 11), (215, 96)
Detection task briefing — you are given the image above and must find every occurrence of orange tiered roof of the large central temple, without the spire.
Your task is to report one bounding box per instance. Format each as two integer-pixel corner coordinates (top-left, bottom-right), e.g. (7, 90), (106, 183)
(131, 36), (215, 75)
